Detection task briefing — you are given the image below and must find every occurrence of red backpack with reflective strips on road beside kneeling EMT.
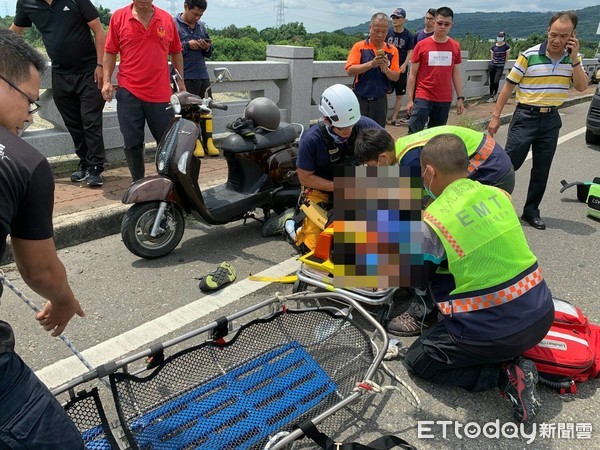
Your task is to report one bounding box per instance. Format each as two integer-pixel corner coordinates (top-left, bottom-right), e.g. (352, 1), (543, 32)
(523, 299), (600, 394)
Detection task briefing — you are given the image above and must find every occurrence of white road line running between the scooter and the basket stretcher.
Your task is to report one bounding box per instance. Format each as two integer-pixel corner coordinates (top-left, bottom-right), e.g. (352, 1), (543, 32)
(36, 257), (300, 389)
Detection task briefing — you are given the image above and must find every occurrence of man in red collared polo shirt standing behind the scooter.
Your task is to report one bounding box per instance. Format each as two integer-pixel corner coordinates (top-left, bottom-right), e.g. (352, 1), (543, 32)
(102, 0), (185, 181)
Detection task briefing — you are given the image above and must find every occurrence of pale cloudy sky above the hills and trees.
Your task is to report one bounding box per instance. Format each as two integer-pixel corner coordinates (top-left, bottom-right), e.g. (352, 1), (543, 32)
(84, 0), (597, 33)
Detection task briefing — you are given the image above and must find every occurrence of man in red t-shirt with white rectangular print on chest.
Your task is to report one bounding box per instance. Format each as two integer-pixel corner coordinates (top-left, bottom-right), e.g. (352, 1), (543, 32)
(406, 7), (465, 134)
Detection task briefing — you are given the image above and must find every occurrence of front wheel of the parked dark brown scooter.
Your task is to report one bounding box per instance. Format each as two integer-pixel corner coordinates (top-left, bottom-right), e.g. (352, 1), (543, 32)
(121, 202), (185, 259)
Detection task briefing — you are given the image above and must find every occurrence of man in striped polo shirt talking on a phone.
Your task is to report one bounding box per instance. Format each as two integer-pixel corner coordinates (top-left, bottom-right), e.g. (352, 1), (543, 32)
(488, 11), (587, 230)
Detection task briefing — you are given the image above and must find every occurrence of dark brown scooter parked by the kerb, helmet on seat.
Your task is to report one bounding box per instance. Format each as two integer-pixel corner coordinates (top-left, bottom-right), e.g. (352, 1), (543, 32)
(121, 68), (302, 259)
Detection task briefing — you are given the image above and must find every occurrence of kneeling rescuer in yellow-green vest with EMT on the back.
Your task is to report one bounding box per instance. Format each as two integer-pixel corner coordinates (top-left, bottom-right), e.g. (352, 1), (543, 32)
(398, 134), (554, 424)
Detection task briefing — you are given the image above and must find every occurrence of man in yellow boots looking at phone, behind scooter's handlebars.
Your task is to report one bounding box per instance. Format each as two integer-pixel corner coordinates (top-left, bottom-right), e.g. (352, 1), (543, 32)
(173, 0), (219, 156)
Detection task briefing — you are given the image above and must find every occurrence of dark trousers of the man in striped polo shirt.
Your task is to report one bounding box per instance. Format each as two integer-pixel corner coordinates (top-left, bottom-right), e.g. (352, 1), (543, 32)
(504, 108), (562, 217)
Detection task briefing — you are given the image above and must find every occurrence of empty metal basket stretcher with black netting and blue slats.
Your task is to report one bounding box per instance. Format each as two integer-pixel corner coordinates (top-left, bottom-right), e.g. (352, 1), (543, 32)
(53, 292), (388, 450)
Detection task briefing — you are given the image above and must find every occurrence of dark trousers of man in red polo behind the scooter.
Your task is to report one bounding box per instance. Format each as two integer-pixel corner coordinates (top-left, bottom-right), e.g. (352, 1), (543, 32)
(115, 87), (173, 153)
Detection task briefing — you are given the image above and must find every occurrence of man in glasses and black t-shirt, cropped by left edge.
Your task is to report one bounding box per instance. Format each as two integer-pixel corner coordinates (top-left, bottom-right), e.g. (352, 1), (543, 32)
(0, 30), (84, 450)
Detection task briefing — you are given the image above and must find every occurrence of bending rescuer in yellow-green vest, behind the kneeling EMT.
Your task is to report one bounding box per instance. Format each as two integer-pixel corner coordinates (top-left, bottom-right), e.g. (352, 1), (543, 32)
(355, 125), (515, 194)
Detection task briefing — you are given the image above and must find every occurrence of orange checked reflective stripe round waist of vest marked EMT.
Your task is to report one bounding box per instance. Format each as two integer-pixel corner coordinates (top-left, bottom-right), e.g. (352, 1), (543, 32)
(438, 267), (543, 316)
